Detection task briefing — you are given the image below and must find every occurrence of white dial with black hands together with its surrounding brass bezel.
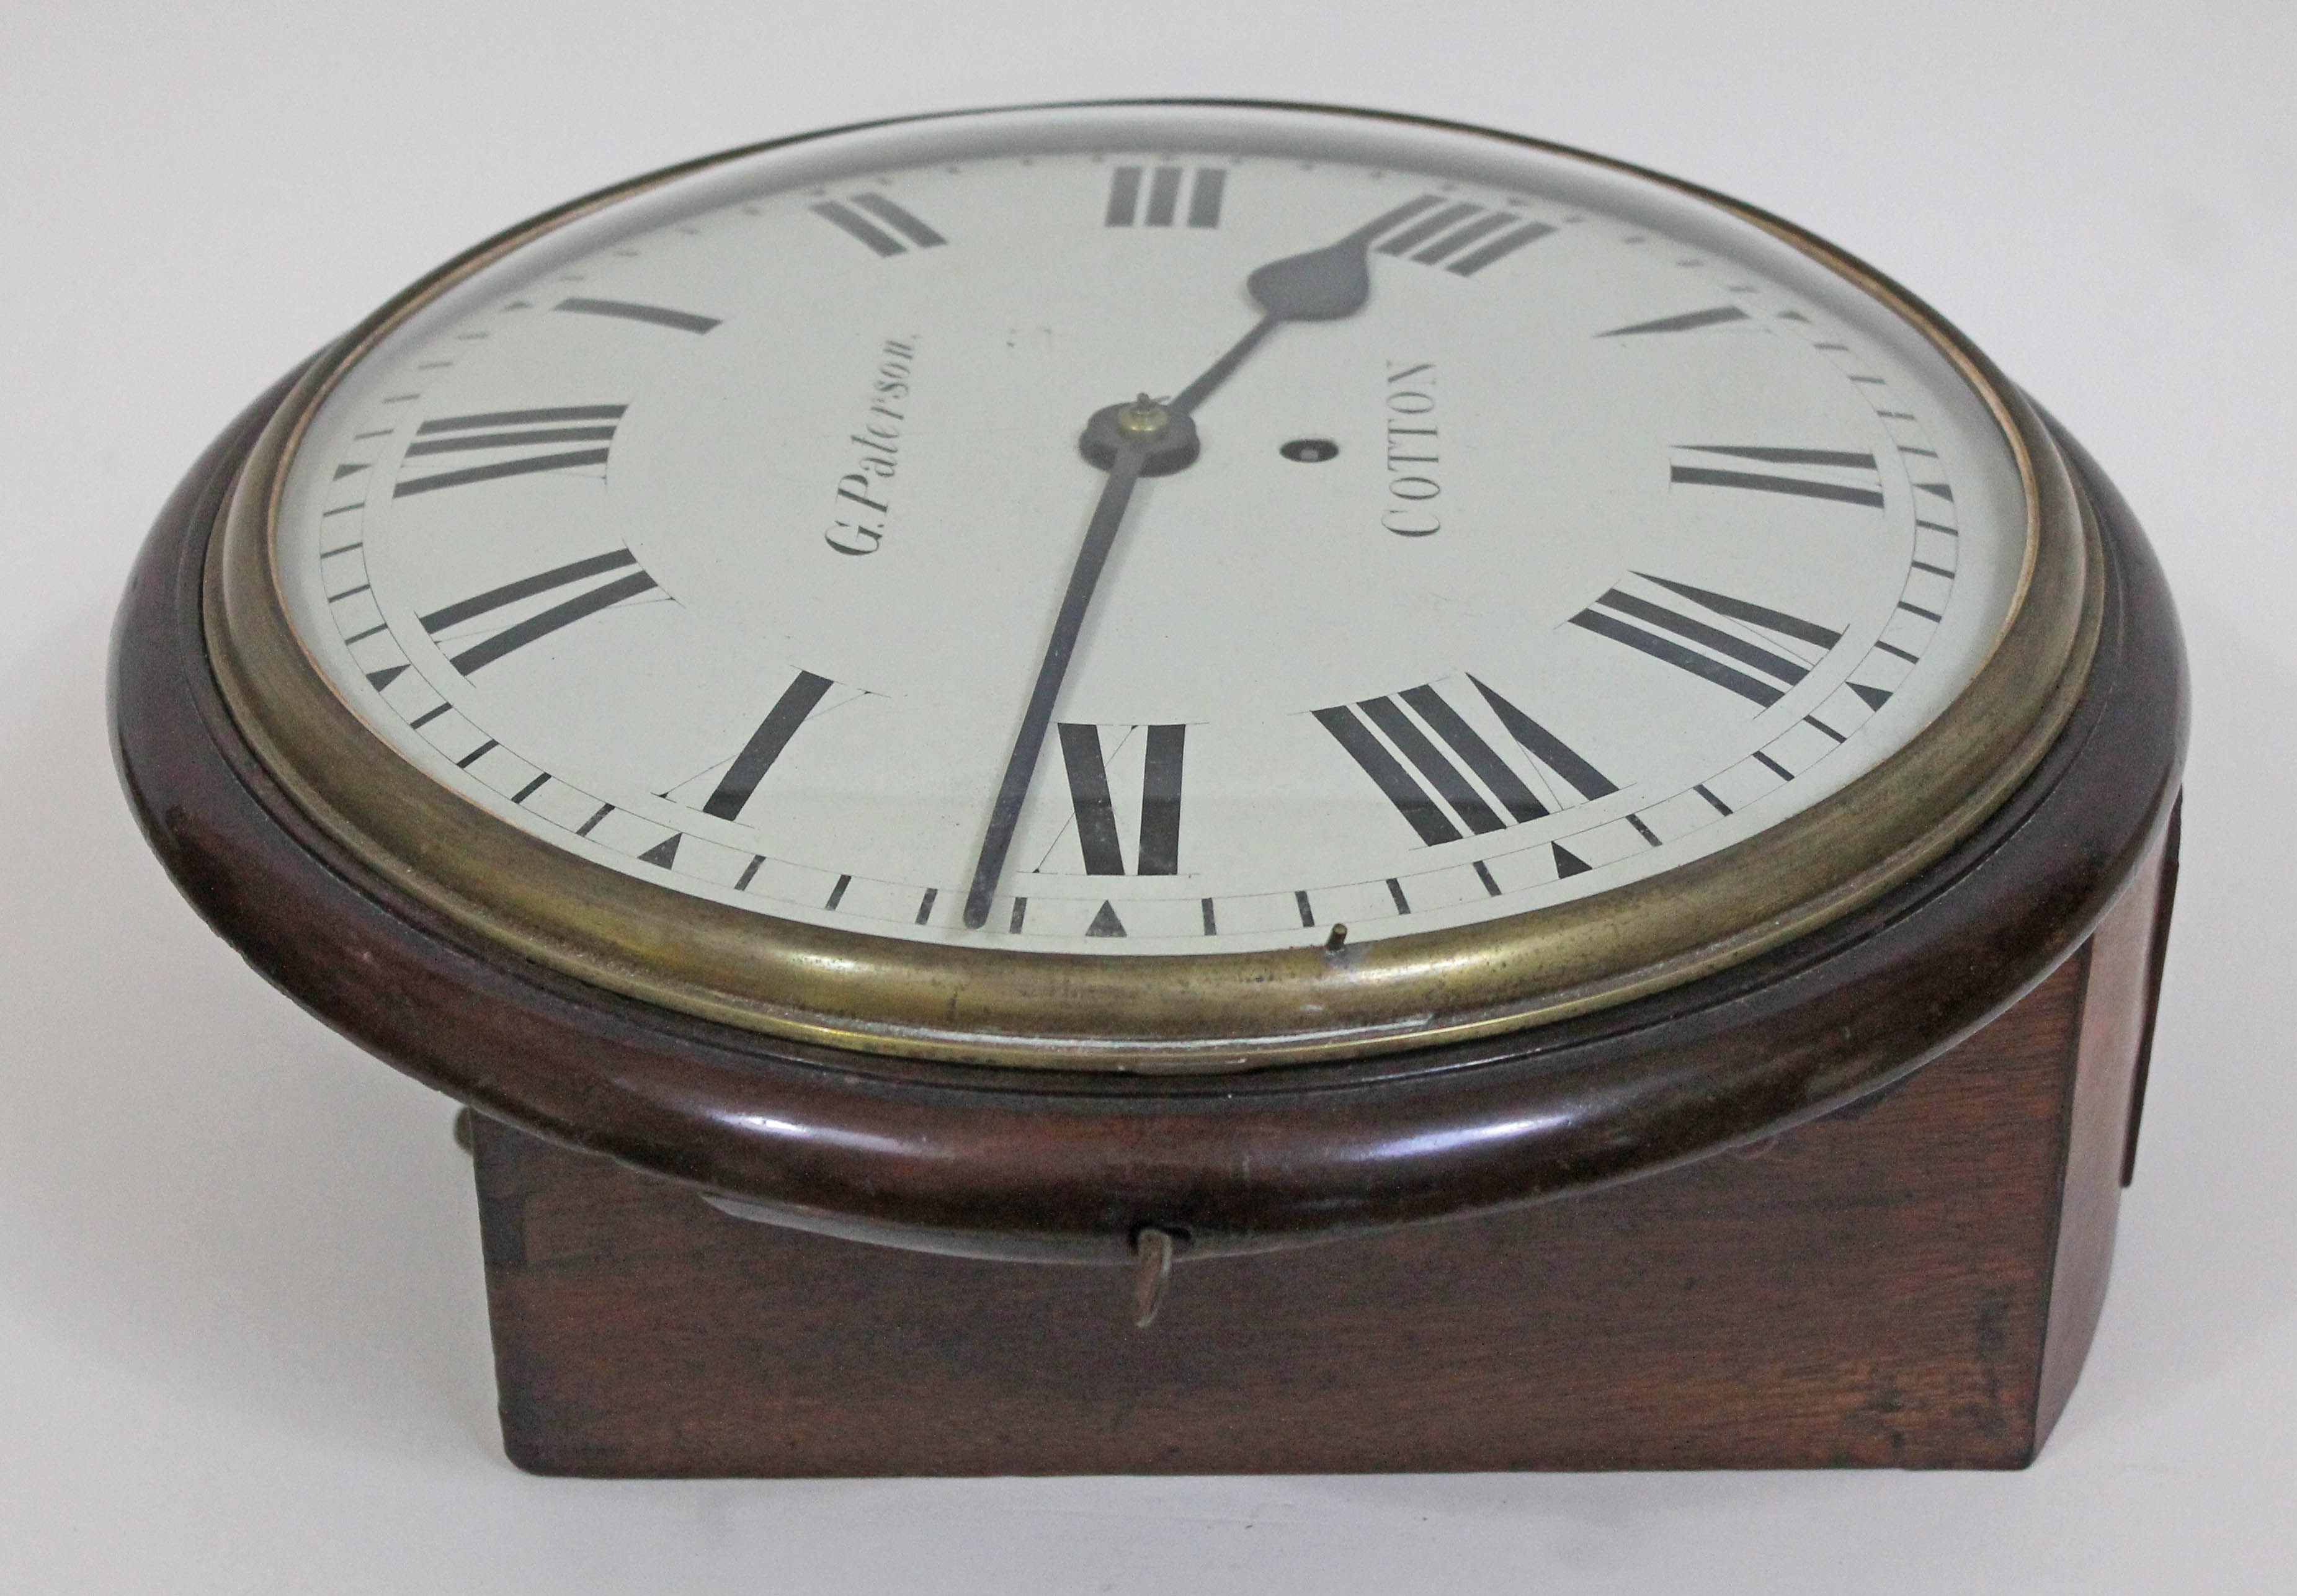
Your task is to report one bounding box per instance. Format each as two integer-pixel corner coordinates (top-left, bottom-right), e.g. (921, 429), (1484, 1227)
(212, 105), (2085, 1068)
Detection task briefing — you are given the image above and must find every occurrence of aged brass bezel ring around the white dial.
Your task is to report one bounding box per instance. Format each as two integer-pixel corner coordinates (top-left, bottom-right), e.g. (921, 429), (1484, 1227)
(205, 108), (2102, 1072)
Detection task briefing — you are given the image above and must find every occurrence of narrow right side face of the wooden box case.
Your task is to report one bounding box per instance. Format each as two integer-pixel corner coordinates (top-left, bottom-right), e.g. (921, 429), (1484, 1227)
(2035, 834), (2169, 1447)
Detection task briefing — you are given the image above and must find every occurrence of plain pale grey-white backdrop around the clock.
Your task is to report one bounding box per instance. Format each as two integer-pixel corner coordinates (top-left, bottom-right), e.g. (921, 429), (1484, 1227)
(0, 0), (2297, 1596)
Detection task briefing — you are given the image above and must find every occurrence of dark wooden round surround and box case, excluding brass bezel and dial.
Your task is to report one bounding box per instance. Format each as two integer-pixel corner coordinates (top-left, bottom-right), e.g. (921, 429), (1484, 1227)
(112, 362), (2187, 1474)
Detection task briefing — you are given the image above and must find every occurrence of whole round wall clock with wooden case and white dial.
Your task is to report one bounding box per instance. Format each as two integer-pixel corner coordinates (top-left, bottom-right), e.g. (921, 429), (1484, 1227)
(115, 104), (2185, 1472)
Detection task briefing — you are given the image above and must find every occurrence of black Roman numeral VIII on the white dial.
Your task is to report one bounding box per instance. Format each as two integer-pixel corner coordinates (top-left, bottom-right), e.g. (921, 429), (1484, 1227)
(1316, 675), (1620, 847)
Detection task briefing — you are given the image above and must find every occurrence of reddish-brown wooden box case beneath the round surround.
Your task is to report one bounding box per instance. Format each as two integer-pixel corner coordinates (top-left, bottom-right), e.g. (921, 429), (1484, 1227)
(476, 829), (2175, 1476)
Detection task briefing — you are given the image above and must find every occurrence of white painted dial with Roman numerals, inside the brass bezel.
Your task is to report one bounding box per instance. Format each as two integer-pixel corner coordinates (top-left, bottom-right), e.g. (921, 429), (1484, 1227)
(278, 108), (2028, 955)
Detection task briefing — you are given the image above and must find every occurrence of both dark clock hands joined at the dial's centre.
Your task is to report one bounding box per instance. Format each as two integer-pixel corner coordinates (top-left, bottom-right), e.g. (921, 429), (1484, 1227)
(946, 197), (1434, 930)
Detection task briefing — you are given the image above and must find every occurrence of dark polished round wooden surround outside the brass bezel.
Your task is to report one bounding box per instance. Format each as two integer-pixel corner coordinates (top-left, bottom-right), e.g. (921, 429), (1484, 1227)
(112, 354), (2187, 1263)
